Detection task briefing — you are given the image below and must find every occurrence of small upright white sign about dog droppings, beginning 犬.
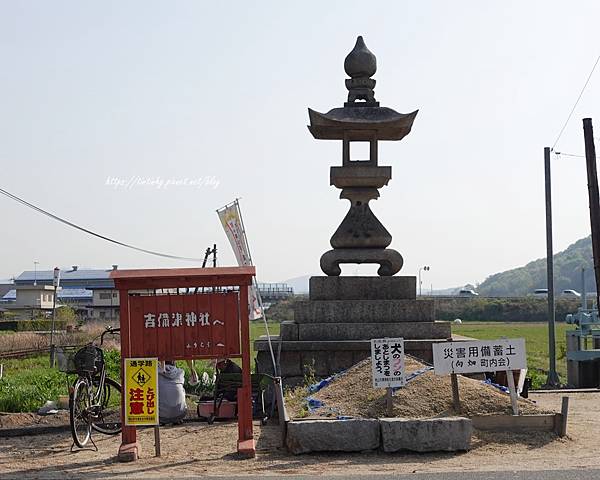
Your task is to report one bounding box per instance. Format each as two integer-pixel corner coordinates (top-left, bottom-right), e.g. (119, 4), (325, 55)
(371, 338), (406, 388)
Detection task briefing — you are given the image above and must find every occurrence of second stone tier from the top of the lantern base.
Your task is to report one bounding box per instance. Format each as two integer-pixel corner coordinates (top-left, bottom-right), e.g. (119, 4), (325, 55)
(294, 300), (435, 323)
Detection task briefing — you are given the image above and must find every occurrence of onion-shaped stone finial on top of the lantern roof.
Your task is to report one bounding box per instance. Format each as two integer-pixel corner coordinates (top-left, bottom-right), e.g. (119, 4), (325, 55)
(344, 36), (379, 107)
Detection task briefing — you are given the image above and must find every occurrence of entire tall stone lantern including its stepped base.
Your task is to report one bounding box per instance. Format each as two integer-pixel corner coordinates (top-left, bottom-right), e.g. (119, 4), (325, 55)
(256, 37), (450, 384)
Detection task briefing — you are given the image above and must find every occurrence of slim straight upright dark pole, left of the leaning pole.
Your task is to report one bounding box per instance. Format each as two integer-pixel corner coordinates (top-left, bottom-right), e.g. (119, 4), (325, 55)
(544, 147), (560, 388)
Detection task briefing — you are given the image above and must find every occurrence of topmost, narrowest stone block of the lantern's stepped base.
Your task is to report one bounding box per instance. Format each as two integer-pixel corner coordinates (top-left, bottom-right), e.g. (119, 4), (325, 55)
(309, 276), (417, 300)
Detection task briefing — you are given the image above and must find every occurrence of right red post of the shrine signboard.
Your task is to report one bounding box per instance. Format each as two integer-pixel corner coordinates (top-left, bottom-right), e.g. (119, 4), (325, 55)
(237, 285), (256, 457)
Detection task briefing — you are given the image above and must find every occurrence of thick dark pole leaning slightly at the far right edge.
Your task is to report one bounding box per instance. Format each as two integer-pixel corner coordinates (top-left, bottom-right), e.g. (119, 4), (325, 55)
(583, 118), (600, 307)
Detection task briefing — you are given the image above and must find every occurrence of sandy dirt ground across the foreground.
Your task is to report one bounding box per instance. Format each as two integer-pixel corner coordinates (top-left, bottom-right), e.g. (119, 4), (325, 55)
(0, 393), (600, 479)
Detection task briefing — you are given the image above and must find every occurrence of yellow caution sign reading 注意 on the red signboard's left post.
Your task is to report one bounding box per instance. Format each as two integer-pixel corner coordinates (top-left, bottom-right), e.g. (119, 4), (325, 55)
(123, 358), (158, 425)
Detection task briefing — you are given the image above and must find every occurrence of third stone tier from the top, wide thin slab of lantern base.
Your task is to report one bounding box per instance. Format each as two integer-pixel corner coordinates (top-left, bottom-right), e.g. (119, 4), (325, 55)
(281, 322), (451, 341)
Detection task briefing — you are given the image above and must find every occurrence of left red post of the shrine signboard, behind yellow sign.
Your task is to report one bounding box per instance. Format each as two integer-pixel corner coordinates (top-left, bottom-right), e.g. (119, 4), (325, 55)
(118, 290), (140, 462)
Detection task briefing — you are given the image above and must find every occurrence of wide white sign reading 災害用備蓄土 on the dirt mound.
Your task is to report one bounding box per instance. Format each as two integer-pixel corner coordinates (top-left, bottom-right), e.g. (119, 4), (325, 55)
(433, 338), (527, 375)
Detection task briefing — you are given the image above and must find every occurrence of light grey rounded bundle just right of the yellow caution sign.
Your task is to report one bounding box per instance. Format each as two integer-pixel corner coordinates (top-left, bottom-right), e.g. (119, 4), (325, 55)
(158, 365), (187, 423)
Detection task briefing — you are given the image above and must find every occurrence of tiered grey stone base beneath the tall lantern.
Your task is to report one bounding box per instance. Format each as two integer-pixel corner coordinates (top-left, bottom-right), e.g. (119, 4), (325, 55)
(255, 276), (451, 385)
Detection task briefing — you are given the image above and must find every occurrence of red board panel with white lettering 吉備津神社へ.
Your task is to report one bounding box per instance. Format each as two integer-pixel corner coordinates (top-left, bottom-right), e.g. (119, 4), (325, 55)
(129, 291), (240, 360)
